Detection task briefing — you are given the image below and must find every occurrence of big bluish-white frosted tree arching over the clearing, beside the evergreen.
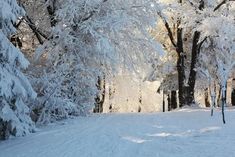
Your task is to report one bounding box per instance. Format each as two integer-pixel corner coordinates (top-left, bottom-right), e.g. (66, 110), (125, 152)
(35, 0), (158, 121)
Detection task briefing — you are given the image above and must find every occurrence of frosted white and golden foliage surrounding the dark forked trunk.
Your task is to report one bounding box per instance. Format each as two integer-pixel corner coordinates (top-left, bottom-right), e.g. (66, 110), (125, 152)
(149, 0), (235, 92)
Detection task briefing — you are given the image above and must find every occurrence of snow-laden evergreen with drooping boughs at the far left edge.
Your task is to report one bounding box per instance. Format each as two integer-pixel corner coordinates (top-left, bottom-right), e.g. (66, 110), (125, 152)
(0, 0), (36, 139)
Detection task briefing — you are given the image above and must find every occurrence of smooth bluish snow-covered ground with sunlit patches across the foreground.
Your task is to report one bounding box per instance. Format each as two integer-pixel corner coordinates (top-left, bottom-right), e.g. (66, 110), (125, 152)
(0, 109), (235, 157)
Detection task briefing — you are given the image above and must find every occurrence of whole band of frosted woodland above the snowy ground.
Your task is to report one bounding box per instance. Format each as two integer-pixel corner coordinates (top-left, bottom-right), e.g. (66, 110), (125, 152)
(0, 0), (235, 139)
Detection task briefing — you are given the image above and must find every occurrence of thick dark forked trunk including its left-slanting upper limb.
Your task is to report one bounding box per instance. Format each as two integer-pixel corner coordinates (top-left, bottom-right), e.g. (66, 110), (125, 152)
(160, 0), (205, 107)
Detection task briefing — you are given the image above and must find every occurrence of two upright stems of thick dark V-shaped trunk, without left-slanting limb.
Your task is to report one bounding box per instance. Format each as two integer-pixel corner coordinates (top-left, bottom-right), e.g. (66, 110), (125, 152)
(176, 0), (204, 107)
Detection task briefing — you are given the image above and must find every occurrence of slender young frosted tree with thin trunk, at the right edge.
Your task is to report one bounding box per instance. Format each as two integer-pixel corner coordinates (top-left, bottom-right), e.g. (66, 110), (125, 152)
(198, 4), (235, 123)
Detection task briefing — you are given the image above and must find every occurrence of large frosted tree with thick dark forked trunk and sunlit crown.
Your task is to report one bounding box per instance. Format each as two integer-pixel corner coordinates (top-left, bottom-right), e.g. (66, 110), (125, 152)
(149, 0), (234, 106)
